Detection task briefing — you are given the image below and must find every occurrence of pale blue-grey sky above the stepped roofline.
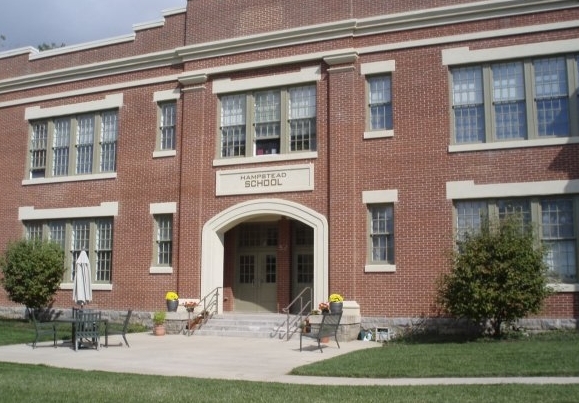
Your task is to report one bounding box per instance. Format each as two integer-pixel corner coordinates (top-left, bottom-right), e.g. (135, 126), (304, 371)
(0, 0), (187, 52)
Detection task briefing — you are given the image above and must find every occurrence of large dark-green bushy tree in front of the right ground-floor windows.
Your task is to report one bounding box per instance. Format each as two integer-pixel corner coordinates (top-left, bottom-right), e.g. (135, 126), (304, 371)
(438, 216), (552, 337)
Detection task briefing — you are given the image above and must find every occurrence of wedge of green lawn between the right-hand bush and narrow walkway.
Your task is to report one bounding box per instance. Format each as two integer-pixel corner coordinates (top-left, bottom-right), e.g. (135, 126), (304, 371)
(291, 332), (579, 378)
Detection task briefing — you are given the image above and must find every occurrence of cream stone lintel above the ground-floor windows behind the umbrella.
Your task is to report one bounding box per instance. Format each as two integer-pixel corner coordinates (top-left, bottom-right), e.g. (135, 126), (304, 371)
(18, 202), (119, 221)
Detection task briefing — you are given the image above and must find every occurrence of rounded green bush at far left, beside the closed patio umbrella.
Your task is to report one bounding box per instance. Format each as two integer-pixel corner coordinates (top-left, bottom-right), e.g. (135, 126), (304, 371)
(0, 240), (64, 309)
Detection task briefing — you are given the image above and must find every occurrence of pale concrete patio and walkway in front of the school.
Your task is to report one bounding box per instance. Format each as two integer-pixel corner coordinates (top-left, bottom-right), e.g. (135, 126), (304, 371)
(0, 333), (579, 385)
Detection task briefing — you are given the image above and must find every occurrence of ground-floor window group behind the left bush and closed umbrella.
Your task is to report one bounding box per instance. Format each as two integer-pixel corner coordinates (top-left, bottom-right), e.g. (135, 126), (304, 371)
(24, 218), (113, 284)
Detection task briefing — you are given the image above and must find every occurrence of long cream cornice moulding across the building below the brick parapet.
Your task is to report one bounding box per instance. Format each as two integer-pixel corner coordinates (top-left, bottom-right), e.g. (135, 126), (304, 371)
(0, 0), (579, 93)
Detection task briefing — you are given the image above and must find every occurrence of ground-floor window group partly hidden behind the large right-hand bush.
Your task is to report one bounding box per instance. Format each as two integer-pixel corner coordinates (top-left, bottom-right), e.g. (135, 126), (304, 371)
(455, 196), (579, 283)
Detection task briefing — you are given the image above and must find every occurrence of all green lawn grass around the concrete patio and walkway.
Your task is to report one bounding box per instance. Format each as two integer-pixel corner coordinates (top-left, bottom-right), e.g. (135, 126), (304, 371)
(0, 320), (579, 403)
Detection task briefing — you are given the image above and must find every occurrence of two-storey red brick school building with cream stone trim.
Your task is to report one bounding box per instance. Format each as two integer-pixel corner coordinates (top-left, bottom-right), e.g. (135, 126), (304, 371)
(0, 0), (579, 328)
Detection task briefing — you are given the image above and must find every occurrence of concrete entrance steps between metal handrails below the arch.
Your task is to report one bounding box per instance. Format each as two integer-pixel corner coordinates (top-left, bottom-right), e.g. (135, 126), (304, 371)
(194, 313), (304, 338)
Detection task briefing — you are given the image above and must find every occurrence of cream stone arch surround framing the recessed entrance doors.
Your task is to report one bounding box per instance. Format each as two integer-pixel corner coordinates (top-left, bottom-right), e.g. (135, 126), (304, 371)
(201, 199), (328, 313)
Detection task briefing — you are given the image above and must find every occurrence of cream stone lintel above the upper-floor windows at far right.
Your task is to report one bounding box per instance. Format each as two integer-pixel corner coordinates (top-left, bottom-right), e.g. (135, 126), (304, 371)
(442, 38), (579, 66)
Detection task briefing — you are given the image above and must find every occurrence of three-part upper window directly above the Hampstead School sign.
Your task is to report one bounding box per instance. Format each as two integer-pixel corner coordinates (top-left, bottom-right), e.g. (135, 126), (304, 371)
(219, 85), (316, 158)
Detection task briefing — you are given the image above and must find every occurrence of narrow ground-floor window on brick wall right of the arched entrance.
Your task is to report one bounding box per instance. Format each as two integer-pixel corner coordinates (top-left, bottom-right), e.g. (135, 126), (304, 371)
(369, 204), (394, 264)
